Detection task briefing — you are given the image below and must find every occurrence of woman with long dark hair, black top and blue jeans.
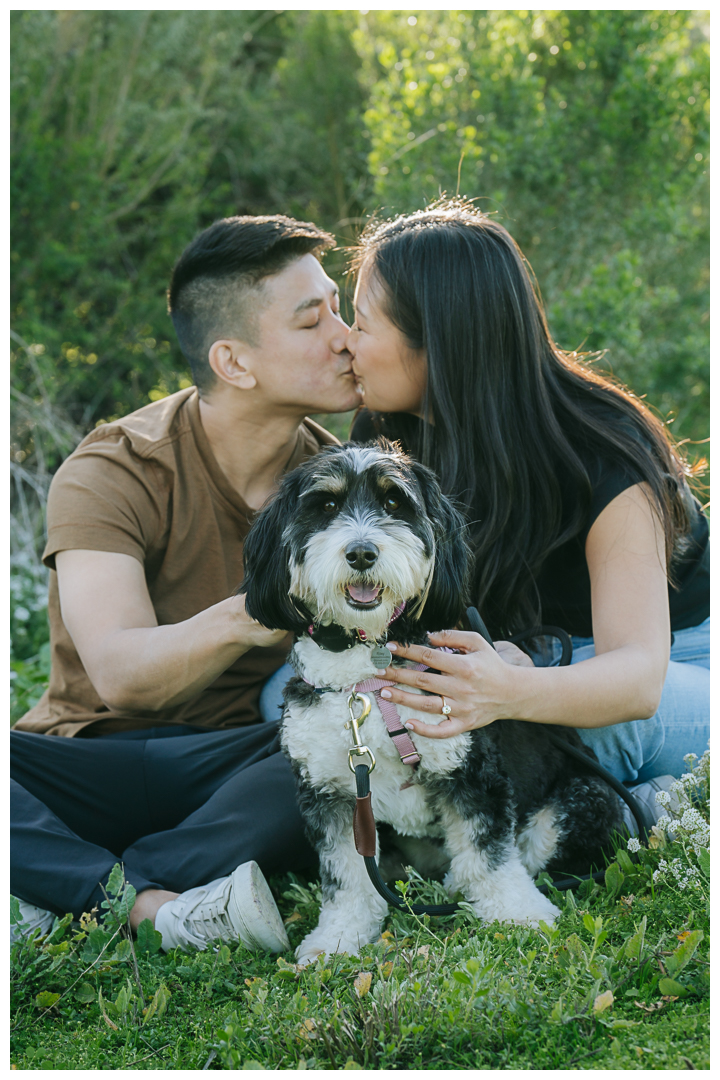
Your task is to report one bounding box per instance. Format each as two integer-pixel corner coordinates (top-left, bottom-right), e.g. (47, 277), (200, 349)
(348, 201), (709, 799)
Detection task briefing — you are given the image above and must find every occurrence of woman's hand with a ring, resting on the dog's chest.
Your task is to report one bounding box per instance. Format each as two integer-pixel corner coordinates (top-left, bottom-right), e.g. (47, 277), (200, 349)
(381, 630), (532, 739)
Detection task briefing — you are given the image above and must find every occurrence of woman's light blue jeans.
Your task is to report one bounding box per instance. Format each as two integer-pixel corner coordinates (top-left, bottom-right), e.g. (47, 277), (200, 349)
(260, 619), (710, 784)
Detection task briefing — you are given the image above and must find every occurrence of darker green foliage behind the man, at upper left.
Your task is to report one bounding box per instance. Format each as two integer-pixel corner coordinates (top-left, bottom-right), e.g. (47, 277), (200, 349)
(12, 11), (363, 438)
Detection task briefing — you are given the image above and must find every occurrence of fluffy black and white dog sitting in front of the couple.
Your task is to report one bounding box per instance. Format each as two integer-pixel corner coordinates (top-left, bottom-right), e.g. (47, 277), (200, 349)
(241, 440), (621, 963)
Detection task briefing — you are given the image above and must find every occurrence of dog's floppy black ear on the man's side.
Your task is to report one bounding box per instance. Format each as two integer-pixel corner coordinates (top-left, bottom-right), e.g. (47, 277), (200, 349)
(236, 471), (311, 634)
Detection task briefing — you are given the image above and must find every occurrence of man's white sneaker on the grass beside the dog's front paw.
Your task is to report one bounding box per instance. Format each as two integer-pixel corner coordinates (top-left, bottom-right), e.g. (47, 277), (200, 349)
(155, 862), (290, 953)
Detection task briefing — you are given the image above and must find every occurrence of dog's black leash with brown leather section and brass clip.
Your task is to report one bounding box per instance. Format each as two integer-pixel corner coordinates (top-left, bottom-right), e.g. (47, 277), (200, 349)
(345, 607), (653, 915)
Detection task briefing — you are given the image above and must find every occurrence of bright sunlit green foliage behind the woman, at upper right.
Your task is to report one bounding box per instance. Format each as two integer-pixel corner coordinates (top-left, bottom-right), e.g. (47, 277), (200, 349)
(355, 10), (709, 449)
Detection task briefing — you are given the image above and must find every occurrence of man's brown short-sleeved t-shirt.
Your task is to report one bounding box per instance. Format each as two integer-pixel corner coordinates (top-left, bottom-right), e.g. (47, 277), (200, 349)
(15, 387), (337, 735)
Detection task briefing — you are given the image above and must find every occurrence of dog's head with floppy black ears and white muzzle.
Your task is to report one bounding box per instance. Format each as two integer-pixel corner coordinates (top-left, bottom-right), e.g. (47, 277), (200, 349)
(241, 440), (467, 637)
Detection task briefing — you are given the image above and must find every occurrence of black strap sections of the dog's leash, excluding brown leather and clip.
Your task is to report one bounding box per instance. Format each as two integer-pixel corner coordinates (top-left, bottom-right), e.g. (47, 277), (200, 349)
(355, 607), (654, 915)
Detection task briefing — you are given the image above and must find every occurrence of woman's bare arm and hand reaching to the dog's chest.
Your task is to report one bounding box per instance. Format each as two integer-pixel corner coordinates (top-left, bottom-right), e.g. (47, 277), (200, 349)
(383, 484), (670, 738)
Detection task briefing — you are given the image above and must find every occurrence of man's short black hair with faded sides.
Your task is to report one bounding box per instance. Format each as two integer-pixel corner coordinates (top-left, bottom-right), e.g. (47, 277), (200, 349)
(167, 214), (335, 393)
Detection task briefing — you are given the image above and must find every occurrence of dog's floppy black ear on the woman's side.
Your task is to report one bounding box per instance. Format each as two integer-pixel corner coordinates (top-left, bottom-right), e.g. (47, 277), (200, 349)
(408, 462), (471, 631)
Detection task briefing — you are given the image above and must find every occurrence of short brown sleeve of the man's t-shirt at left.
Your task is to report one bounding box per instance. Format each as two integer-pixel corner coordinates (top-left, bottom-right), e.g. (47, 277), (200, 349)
(42, 435), (166, 569)
